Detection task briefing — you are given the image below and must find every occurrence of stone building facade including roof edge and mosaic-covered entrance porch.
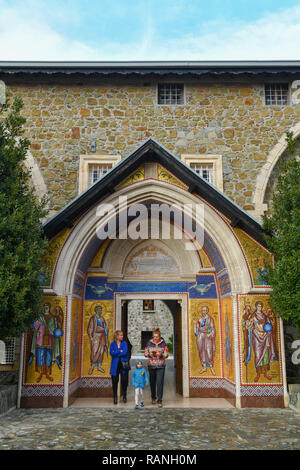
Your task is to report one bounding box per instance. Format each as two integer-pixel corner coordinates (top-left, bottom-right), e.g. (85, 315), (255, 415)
(0, 62), (300, 406)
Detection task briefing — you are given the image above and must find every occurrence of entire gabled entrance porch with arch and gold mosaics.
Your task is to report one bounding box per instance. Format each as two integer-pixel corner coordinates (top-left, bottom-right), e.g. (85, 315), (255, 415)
(20, 142), (286, 407)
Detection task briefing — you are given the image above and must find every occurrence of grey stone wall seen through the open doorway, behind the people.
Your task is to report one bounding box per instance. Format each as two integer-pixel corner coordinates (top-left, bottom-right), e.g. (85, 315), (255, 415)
(128, 300), (174, 355)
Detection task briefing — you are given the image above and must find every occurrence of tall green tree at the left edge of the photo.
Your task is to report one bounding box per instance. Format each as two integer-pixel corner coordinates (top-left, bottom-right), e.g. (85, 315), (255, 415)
(0, 93), (48, 339)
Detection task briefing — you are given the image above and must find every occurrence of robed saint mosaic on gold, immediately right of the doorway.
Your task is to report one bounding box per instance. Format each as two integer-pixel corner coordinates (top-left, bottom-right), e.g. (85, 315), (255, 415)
(194, 306), (216, 375)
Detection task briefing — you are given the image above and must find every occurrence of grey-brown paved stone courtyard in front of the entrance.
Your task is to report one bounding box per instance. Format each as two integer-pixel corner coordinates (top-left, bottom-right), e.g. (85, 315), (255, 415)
(0, 408), (300, 450)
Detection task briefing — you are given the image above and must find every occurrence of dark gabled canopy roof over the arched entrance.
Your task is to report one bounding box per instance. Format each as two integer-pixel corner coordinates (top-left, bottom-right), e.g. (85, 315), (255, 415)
(43, 138), (266, 246)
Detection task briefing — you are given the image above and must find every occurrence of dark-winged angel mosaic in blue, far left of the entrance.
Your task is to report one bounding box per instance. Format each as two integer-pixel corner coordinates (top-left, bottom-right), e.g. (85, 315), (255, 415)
(26, 302), (64, 382)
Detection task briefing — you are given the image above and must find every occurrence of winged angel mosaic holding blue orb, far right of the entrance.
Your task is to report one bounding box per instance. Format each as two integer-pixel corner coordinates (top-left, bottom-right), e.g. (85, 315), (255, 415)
(242, 301), (278, 382)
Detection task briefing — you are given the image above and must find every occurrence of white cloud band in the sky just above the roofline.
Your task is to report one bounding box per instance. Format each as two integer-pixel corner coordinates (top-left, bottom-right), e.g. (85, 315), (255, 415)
(0, 0), (300, 61)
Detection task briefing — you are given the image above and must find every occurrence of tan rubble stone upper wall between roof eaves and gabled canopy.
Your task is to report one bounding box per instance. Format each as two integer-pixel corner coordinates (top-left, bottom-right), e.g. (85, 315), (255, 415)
(0, 77), (300, 211)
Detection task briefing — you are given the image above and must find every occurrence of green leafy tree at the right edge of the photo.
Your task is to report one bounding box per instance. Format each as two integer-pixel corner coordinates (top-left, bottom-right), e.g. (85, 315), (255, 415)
(262, 132), (300, 332)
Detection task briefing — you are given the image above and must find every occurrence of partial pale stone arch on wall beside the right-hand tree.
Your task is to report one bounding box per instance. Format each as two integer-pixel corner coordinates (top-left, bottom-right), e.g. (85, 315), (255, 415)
(253, 122), (300, 219)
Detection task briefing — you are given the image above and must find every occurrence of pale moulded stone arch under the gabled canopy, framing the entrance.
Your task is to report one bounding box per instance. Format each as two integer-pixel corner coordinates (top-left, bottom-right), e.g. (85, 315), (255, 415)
(53, 180), (251, 295)
